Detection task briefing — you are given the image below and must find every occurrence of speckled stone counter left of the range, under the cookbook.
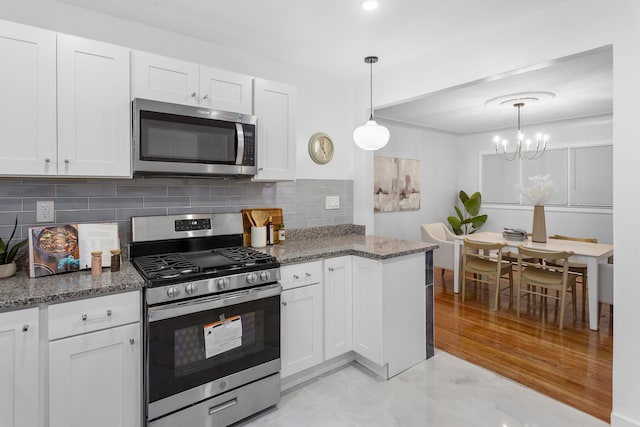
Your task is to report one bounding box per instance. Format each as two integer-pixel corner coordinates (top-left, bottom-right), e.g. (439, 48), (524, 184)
(0, 260), (144, 311)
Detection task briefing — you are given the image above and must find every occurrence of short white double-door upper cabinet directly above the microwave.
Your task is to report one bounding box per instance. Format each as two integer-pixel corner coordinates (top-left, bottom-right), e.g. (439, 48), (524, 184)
(133, 52), (252, 114)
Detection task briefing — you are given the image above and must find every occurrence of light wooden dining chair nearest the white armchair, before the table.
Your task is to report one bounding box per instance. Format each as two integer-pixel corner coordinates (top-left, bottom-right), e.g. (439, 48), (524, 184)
(462, 237), (513, 310)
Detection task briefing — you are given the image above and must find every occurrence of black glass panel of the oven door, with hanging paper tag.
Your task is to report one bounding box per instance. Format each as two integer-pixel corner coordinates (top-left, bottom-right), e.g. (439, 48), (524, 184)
(148, 296), (280, 402)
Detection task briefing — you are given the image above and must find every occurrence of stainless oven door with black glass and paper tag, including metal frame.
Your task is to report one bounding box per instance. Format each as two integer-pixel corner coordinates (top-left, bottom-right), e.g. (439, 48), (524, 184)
(145, 283), (281, 420)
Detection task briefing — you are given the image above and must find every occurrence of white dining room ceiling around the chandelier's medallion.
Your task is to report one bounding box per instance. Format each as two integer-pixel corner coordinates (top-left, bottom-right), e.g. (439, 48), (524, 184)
(375, 46), (613, 134)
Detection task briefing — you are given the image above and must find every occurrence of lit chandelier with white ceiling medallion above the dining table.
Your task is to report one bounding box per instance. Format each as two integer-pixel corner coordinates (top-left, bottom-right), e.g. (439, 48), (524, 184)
(485, 92), (555, 161)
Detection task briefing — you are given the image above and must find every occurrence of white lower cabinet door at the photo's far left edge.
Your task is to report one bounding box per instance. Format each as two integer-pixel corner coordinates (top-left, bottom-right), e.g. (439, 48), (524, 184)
(0, 308), (40, 427)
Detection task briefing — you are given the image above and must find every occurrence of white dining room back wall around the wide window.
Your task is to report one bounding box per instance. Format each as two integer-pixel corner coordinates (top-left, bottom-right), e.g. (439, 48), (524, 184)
(456, 114), (613, 243)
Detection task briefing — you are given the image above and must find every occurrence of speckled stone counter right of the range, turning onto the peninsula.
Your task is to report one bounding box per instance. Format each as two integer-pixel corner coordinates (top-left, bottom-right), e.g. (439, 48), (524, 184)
(263, 234), (438, 265)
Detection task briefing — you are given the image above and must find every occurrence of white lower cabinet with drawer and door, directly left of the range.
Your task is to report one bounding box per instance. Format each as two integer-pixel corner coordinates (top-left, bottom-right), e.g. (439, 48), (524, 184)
(48, 292), (142, 427)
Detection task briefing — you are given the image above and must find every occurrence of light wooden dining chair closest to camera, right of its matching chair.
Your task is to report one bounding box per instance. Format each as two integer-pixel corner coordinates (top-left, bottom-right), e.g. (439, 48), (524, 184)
(516, 245), (577, 329)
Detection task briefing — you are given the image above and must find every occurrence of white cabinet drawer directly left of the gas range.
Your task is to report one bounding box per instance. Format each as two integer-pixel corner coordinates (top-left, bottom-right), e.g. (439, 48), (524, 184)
(48, 292), (141, 340)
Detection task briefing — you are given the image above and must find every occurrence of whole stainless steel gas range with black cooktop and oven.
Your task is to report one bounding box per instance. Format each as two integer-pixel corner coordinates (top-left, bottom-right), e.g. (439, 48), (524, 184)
(130, 213), (281, 427)
